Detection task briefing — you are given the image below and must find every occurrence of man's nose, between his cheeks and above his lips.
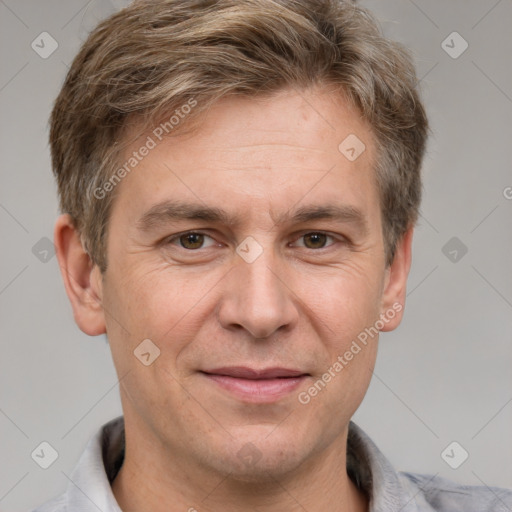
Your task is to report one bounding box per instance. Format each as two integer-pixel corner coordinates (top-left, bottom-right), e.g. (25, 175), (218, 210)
(218, 250), (299, 339)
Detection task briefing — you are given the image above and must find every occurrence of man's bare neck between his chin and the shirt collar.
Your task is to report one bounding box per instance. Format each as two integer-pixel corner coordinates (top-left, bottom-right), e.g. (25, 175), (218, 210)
(112, 417), (368, 512)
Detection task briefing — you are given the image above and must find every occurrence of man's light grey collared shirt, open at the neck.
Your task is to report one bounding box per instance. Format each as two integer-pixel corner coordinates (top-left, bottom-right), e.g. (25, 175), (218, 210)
(34, 416), (512, 512)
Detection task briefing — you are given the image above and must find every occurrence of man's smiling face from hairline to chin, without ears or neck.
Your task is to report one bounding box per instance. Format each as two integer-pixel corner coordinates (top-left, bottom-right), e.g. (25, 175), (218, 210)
(92, 90), (406, 479)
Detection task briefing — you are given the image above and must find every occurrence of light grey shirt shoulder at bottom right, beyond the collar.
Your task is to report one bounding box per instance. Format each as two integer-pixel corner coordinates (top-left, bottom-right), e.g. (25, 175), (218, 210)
(399, 472), (512, 512)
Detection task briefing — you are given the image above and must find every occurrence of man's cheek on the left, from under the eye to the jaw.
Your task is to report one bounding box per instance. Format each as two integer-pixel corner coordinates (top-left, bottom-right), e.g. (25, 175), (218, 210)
(104, 266), (204, 418)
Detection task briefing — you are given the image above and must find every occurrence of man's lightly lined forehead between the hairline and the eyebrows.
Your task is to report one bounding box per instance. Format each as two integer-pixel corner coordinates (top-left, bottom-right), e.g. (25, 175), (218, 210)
(109, 89), (377, 230)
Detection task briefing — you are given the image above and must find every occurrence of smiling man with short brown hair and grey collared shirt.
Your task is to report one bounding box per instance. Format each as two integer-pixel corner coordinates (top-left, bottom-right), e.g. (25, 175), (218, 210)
(34, 0), (512, 512)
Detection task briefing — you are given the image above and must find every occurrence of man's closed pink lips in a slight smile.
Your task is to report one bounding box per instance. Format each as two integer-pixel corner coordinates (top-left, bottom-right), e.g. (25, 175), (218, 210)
(200, 366), (310, 403)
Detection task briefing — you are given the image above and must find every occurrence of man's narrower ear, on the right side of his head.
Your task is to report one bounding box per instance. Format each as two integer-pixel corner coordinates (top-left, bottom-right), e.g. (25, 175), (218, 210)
(380, 227), (414, 332)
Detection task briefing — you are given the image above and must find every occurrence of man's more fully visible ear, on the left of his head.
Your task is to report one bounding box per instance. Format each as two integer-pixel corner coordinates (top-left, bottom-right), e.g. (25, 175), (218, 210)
(54, 214), (106, 336)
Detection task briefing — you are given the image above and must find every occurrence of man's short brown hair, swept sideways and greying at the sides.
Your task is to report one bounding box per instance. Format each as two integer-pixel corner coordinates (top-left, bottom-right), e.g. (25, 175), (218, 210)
(50, 0), (428, 272)
